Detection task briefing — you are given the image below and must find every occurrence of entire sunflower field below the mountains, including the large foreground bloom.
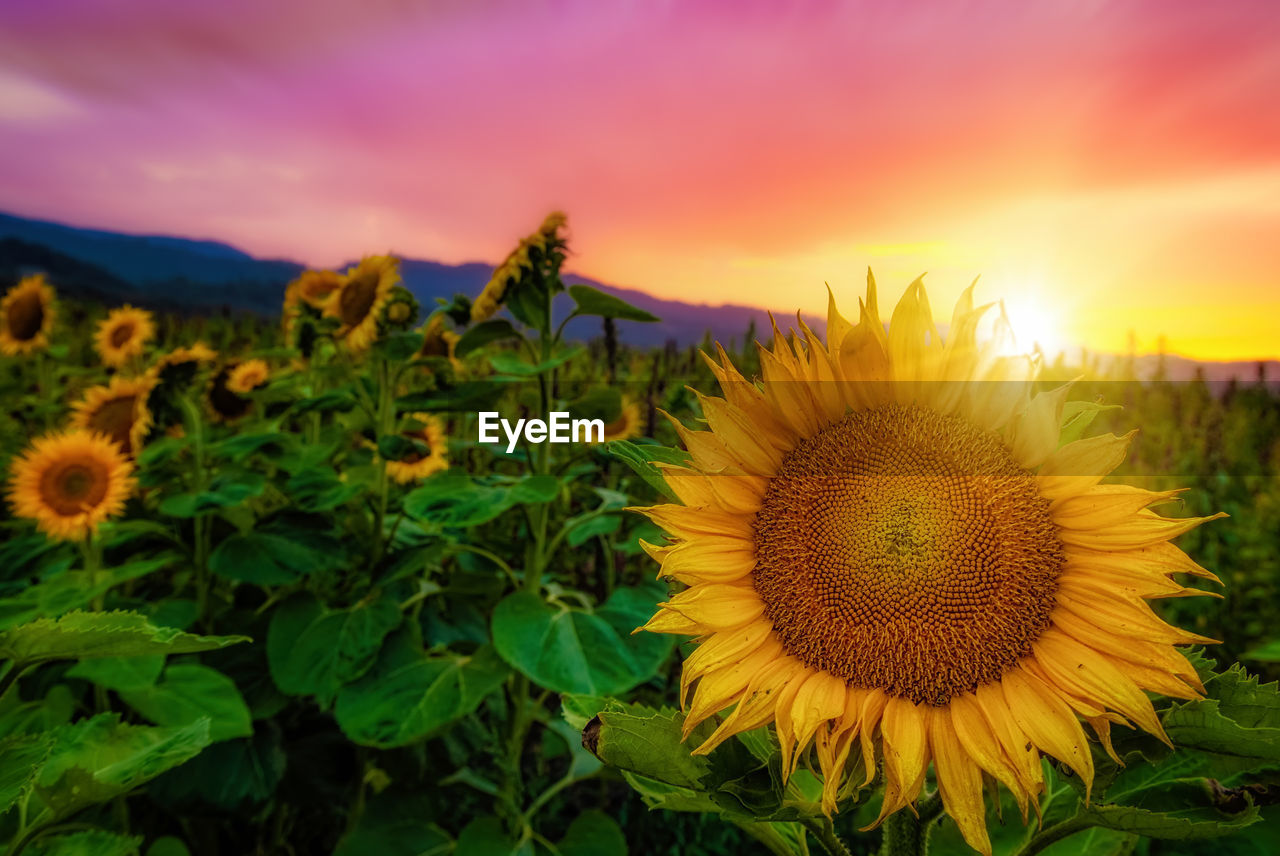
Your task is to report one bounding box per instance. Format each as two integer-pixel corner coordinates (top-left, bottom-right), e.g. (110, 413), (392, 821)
(0, 208), (1280, 856)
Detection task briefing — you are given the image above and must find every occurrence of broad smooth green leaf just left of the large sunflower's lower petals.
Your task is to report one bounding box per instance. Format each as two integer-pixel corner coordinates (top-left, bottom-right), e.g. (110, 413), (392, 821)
(493, 586), (673, 695)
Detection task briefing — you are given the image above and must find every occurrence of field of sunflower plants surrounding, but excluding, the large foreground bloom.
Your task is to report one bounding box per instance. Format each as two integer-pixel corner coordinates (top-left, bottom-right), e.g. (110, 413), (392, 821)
(0, 215), (1280, 856)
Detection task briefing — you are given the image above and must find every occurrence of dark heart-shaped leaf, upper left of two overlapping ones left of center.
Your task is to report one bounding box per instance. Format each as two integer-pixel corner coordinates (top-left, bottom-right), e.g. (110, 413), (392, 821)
(266, 594), (401, 708)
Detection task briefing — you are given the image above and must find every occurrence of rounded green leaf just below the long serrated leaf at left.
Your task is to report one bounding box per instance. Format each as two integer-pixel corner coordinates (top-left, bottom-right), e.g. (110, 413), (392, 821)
(119, 663), (253, 743)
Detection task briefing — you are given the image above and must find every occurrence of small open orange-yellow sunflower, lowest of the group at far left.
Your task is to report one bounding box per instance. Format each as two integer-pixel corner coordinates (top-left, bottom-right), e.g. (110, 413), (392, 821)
(9, 430), (133, 539)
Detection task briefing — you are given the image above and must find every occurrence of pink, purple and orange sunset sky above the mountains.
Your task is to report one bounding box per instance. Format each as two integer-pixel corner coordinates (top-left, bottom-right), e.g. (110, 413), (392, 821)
(0, 0), (1280, 360)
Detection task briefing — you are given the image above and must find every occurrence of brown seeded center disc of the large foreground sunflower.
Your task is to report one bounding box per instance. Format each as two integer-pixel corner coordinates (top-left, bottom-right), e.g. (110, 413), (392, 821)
(753, 406), (1064, 705)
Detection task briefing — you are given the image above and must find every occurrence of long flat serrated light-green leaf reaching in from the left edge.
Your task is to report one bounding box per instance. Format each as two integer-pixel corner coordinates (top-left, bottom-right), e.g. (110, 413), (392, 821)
(0, 612), (251, 663)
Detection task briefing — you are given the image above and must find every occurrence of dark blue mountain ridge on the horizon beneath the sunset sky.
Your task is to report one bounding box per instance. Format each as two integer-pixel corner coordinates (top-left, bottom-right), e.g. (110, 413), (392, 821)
(0, 208), (798, 347)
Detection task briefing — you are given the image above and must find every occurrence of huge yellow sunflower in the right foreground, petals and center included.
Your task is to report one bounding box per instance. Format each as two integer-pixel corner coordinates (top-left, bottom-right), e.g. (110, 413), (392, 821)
(639, 276), (1221, 853)
